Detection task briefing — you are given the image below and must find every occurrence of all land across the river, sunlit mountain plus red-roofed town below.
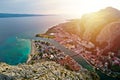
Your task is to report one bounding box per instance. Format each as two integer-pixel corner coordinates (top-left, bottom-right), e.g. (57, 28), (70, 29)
(43, 7), (120, 77)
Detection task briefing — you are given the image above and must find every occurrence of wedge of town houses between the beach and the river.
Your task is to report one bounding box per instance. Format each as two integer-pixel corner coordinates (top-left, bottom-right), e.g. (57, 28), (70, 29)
(28, 40), (82, 71)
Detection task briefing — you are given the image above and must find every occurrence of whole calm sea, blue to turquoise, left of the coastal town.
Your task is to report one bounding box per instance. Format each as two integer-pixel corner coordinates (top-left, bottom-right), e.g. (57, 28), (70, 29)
(0, 16), (66, 65)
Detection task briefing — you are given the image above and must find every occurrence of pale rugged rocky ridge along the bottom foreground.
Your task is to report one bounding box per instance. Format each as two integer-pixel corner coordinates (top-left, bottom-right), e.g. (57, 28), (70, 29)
(0, 61), (99, 80)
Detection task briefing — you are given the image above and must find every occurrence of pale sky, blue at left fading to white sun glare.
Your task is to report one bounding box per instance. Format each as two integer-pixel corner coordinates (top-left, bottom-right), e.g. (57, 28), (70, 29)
(0, 0), (120, 15)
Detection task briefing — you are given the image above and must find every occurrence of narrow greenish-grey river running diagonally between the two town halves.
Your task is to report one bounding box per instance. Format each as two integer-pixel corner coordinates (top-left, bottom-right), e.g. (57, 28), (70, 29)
(36, 38), (119, 80)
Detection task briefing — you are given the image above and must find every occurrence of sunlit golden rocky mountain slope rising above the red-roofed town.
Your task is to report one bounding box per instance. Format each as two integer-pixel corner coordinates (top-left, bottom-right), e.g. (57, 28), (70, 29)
(46, 7), (120, 51)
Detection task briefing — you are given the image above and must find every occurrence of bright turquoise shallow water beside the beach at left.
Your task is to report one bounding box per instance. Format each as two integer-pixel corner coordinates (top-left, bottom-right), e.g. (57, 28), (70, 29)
(0, 37), (31, 65)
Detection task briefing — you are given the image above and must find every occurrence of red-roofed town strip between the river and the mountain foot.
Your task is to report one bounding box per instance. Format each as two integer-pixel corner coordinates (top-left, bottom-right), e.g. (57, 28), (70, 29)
(46, 25), (120, 77)
